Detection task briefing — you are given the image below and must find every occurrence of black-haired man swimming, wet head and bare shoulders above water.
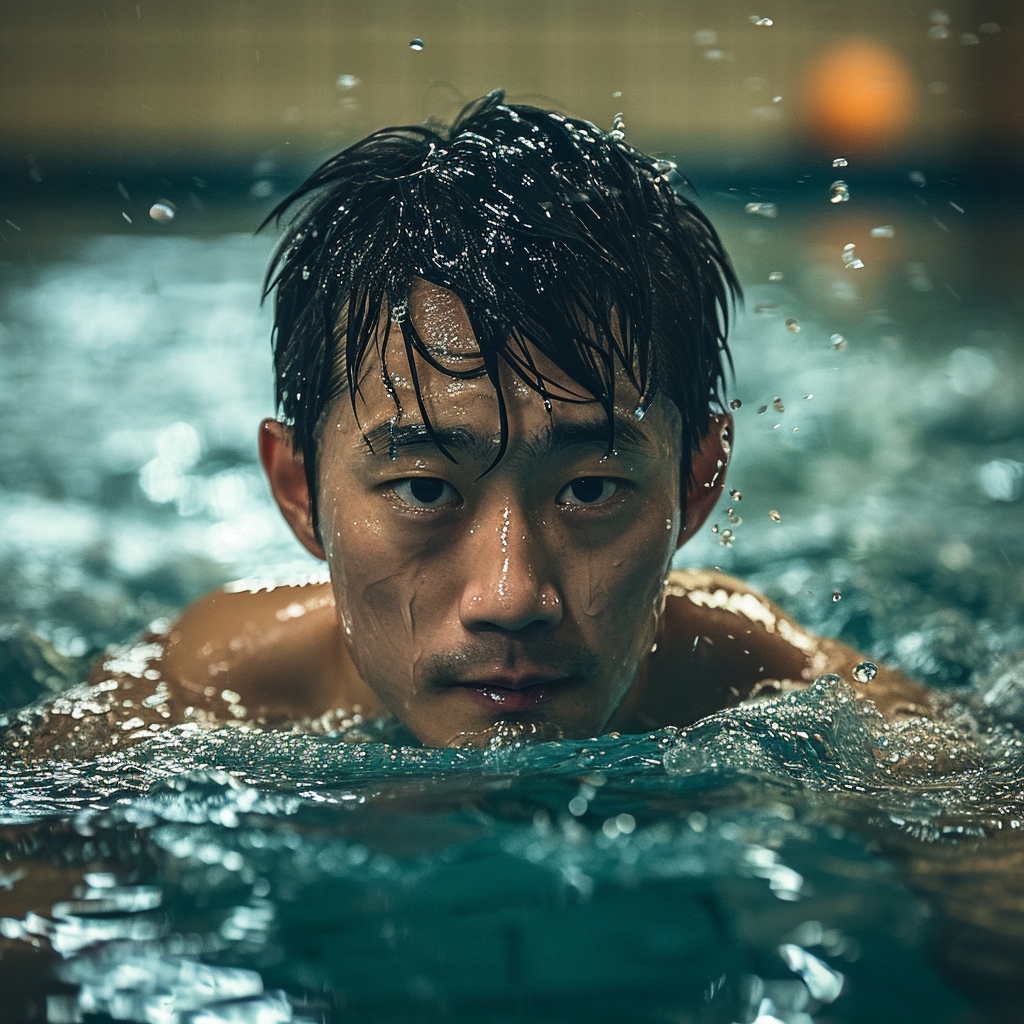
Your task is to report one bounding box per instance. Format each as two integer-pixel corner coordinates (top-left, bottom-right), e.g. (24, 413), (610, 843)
(7, 92), (929, 756)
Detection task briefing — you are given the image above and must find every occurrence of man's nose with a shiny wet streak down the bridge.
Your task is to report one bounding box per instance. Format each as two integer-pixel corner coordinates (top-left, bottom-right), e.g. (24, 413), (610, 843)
(459, 505), (562, 633)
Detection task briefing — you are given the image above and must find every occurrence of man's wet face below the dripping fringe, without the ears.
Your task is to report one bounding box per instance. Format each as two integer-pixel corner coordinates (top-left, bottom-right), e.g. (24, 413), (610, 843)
(319, 283), (680, 746)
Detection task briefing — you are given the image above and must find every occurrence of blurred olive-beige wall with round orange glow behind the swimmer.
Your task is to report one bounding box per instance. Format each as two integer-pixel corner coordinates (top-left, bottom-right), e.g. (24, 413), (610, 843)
(0, 0), (1024, 173)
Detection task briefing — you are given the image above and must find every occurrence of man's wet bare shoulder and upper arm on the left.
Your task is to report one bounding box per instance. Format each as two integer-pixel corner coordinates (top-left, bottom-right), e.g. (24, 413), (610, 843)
(5, 581), (375, 758)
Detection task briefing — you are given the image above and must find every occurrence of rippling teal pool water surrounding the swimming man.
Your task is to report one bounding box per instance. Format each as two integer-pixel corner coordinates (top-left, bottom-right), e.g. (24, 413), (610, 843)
(0, 186), (1024, 1024)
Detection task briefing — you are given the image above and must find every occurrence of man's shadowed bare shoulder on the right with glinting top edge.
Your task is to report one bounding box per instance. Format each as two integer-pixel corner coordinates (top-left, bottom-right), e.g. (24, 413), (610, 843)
(616, 569), (932, 728)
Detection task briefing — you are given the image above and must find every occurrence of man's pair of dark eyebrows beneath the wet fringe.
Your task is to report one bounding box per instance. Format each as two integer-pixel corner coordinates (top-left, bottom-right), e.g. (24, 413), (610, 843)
(365, 415), (651, 461)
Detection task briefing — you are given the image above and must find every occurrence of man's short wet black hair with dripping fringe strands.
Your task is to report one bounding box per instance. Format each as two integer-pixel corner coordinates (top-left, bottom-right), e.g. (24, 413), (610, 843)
(264, 90), (740, 521)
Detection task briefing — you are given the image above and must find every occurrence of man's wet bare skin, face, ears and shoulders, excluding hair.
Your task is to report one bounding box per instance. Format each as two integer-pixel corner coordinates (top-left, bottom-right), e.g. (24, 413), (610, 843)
(9, 284), (928, 754)
